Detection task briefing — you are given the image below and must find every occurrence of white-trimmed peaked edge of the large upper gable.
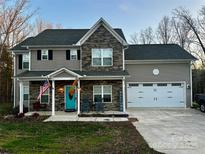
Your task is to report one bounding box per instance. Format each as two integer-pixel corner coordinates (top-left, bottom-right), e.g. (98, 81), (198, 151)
(76, 18), (127, 45)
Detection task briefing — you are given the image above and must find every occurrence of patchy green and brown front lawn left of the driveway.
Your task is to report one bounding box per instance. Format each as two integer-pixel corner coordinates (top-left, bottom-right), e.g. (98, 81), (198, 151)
(0, 119), (162, 154)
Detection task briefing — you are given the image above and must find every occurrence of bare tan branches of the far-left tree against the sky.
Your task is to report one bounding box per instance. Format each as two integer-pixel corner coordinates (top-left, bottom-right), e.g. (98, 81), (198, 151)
(0, 0), (35, 57)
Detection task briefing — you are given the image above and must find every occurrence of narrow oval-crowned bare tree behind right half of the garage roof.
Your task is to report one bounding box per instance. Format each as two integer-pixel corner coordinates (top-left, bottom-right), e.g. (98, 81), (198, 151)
(156, 16), (173, 44)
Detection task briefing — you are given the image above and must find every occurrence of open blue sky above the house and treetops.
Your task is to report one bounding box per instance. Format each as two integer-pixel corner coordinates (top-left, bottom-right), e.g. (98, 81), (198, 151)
(29, 0), (205, 40)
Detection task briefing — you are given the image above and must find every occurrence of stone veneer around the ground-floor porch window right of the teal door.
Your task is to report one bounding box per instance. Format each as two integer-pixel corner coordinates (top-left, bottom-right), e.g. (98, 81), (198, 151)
(80, 80), (122, 111)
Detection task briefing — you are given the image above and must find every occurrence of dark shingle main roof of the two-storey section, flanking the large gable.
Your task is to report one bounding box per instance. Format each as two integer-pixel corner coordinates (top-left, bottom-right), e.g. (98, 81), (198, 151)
(12, 28), (125, 50)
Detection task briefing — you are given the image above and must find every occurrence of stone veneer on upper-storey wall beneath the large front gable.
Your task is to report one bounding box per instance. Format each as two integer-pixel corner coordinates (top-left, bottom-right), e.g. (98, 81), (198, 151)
(82, 25), (123, 71)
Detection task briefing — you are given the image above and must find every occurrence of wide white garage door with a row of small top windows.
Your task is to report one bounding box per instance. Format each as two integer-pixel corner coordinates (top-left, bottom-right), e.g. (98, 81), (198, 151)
(127, 83), (185, 107)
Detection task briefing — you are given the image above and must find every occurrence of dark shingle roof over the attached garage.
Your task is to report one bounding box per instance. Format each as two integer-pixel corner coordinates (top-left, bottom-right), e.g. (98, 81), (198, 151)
(125, 44), (196, 60)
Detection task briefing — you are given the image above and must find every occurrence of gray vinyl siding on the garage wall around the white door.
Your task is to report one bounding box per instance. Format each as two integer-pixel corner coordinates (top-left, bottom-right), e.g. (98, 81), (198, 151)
(125, 63), (191, 107)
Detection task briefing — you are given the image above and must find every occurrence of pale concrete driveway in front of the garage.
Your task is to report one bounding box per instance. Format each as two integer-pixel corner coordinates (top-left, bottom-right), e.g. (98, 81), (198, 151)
(127, 108), (205, 154)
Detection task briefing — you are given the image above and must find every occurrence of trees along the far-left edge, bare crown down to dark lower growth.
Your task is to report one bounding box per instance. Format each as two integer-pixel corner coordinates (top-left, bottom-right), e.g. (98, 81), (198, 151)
(0, 0), (35, 102)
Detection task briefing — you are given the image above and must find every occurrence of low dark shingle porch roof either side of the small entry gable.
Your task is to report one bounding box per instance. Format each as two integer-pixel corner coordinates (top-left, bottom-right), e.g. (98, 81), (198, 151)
(15, 70), (129, 77)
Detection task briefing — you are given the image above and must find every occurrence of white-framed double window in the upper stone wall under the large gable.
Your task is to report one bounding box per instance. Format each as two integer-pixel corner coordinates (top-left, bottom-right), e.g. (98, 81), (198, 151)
(92, 48), (113, 66)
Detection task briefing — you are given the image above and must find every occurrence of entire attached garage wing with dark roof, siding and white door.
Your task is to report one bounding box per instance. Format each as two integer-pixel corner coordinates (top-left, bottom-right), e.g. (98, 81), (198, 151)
(125, 44), (196, 108)
